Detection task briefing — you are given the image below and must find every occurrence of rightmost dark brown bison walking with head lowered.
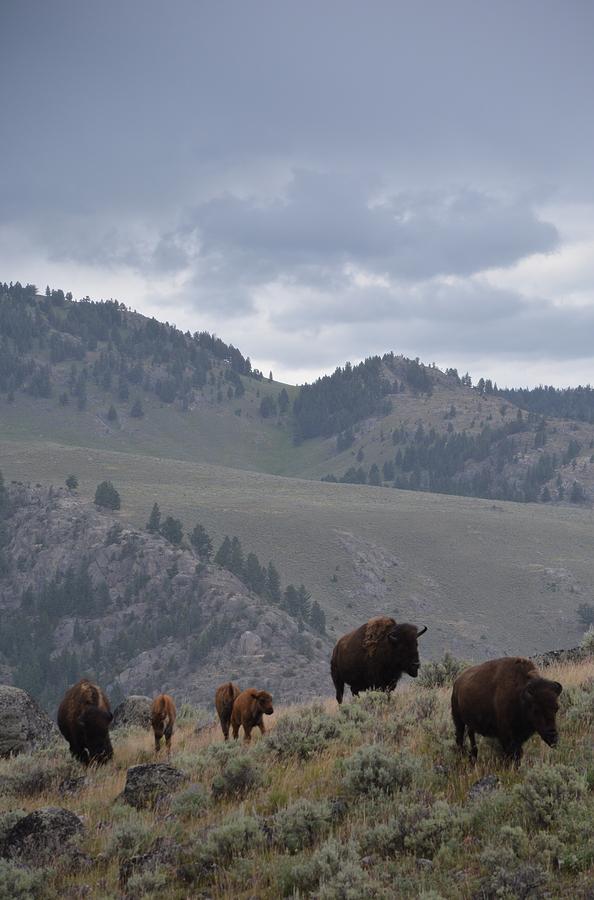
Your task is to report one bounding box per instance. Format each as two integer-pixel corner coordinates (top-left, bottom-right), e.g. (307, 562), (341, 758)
(452, 656), (563, 763)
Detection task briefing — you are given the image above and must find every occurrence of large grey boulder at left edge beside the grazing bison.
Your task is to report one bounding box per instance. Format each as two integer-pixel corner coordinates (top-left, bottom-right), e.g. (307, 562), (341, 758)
(0, 684), (58, 757)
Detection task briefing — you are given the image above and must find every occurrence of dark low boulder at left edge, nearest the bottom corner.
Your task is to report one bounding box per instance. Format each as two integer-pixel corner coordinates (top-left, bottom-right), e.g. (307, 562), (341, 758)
(0, 806), (84, 866)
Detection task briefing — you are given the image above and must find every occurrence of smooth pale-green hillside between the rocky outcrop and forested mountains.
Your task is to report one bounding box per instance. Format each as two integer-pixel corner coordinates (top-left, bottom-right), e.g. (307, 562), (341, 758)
(0, 441), (594, 658)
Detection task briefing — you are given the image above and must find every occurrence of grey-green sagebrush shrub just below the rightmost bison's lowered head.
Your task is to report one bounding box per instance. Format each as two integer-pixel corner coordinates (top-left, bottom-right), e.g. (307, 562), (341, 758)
(514, 765), (586, 826)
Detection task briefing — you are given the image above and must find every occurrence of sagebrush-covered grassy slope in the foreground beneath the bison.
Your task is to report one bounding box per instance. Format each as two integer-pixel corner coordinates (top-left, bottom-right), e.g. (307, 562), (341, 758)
(0, 661), (594, 900)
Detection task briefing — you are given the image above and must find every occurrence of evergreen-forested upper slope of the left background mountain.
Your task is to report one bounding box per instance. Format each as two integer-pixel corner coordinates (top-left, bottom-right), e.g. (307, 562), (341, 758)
(0, 282), (262, 418)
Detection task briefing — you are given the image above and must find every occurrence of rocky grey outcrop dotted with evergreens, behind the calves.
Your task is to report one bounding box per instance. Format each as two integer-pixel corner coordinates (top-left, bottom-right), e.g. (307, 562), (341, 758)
(0, 485), (332, 710)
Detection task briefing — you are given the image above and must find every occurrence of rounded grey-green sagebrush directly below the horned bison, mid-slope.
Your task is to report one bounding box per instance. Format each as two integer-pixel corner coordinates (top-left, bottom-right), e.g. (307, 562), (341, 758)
(338, 744), (417, 794)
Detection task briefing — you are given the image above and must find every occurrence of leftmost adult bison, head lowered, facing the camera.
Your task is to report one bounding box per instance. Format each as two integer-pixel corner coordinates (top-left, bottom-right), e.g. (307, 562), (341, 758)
(58, 678), (113, 765)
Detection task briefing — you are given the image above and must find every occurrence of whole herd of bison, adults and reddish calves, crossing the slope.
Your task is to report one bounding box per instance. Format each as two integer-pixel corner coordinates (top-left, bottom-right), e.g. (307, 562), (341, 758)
(58, 616), (562, 764)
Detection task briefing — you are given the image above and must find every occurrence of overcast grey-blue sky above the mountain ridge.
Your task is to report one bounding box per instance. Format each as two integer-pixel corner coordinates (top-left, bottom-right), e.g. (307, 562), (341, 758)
(0, 0), (594, 385)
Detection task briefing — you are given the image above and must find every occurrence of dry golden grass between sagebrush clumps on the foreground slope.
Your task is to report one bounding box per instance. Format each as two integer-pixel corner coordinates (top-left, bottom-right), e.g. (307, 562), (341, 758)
(0, 659), (594, 900)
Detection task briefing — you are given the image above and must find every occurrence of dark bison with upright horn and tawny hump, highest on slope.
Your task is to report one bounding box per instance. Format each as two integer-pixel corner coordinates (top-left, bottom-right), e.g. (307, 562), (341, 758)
(330, 616), (427, 703)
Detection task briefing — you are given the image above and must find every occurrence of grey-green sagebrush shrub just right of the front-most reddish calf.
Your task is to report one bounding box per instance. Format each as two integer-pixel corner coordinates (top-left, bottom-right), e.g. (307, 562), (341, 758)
(266, 706), (341, 759)
